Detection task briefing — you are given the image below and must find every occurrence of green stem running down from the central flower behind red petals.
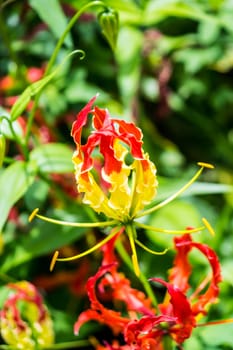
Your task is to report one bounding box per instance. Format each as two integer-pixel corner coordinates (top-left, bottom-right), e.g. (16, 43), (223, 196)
(116, 228), (158, 307)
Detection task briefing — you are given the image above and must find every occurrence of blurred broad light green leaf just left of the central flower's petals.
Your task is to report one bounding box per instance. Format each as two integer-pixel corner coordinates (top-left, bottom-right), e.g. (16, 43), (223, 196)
(30, 143), (74, 174)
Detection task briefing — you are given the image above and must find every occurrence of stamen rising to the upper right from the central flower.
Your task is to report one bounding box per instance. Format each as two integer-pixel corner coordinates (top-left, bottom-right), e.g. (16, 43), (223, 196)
(136, 162), (209, 218)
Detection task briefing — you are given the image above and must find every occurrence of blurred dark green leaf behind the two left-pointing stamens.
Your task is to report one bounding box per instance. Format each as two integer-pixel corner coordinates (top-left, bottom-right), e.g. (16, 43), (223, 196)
(0, 204), (90, 272)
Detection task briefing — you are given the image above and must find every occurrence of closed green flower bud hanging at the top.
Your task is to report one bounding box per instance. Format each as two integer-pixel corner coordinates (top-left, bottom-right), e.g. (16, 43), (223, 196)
(98, 8), (119, 51)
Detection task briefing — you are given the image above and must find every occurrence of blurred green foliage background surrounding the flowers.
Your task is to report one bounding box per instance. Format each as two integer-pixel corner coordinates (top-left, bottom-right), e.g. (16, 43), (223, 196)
(0, 0), (233, 350)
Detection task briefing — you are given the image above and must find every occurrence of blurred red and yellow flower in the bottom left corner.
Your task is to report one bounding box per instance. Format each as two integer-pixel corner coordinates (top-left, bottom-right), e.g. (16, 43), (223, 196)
(0, 281), (54, 350)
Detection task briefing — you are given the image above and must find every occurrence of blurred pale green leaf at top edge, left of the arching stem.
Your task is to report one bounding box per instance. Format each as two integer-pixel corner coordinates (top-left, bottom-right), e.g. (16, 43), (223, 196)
(29, 0), (72, 47)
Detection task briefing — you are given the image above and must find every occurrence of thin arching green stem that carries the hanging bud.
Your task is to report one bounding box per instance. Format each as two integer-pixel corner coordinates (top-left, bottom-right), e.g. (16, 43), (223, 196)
(25, 0), (106, 148)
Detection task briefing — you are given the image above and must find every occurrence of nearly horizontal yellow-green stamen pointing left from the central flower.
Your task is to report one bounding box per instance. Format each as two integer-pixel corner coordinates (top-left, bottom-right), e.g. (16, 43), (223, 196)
(28, 208), (118, 228)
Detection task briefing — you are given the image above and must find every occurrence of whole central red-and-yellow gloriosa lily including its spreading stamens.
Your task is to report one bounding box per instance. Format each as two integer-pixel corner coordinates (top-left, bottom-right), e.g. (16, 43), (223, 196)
(29, 96), (213, 275)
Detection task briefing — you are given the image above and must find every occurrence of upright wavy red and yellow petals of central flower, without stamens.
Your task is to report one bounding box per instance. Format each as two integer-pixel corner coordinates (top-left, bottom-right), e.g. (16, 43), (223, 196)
(72, 97), (157, 221)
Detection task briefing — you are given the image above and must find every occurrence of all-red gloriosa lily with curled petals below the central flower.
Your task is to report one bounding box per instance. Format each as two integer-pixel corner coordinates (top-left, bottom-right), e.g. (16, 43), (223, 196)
(74, 230), (221, 350)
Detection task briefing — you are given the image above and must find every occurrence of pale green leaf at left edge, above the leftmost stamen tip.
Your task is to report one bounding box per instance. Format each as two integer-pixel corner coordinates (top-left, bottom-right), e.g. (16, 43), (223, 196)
(0, 161), (35, 232)
